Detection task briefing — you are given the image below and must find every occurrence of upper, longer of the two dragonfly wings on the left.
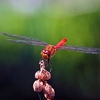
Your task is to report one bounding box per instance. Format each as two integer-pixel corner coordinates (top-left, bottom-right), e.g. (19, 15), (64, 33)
(0, 32), (47, 45)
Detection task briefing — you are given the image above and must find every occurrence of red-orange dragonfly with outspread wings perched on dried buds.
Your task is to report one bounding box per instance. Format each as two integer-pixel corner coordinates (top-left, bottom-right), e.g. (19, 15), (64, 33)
(0, 33), (100, 70)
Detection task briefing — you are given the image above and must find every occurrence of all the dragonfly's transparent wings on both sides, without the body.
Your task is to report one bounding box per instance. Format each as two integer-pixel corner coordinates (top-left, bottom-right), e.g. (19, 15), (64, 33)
(0, 33), (100, 54)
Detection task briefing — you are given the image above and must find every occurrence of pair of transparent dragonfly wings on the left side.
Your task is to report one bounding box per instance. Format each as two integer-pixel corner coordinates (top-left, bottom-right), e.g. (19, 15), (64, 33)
(0, 33), (48, 46)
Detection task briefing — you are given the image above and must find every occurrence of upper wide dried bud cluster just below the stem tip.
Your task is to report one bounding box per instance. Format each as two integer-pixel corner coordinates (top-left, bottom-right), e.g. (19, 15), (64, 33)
(35, 68), (51, 81)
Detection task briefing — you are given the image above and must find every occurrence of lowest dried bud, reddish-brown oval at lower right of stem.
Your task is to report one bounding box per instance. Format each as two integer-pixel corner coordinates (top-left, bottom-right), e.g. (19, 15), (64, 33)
(43, 83), (55, 100)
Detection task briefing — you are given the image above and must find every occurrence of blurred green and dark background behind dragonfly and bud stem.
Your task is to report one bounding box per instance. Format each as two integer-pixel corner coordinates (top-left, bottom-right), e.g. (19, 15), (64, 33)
(0, 0), (100, 100)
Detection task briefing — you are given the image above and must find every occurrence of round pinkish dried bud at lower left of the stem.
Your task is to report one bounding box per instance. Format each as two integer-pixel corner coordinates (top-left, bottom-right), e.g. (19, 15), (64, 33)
(33, 80), (43, 92)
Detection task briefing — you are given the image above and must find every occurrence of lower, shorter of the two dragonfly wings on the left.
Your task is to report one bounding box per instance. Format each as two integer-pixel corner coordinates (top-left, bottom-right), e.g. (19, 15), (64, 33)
(8, 39), (48, 46)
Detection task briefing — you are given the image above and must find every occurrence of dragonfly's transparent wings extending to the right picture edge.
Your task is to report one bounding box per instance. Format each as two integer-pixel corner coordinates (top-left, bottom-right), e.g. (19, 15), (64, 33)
(60, 46), (100, 54)
